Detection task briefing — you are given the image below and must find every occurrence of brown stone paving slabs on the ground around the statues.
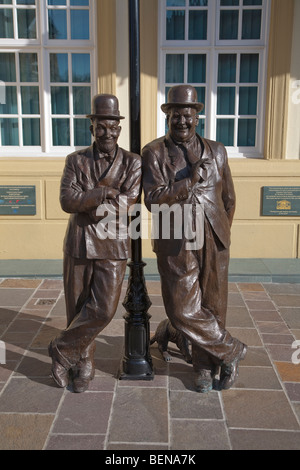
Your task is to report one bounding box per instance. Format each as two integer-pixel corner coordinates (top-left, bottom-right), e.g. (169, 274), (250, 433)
(0, 278), (300, 451)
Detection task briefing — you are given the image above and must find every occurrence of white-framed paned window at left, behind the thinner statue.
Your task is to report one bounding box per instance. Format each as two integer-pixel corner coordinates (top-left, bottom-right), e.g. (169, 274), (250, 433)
(0, 0), (95, 156)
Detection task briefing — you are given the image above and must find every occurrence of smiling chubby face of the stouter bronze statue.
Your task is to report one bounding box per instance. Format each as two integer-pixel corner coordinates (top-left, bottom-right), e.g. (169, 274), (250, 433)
(168, 107), (199, 142)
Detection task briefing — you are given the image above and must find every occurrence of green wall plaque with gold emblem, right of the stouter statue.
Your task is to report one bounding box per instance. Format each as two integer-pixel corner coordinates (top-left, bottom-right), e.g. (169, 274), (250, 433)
(262, 186), (300, 217)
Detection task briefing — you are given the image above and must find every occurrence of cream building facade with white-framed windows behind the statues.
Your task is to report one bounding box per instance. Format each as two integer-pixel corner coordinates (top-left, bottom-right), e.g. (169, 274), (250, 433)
(0, 0), (300, 260)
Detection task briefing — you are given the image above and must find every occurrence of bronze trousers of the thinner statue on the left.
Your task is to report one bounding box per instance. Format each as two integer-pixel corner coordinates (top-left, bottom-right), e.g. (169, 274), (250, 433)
(56, 255), (127, 365)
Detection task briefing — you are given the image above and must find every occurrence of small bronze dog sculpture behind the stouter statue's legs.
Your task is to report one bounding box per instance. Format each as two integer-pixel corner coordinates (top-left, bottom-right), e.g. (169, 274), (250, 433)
(150, 318), (192, 364)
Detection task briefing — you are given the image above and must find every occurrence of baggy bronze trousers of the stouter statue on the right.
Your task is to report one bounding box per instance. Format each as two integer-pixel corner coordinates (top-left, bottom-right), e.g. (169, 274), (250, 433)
(157, 219), (244, 371)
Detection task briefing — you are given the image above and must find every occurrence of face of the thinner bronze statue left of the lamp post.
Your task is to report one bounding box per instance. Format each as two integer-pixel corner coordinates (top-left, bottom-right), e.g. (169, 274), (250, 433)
(91, 118), (121, 153)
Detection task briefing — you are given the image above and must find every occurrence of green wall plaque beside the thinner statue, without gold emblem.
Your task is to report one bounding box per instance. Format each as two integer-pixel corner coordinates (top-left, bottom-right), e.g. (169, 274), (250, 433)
(0, 186), (36, 215)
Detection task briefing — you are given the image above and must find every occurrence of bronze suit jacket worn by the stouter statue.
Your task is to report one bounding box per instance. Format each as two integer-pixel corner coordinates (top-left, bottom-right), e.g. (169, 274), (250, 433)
(142, 134), (235, 255)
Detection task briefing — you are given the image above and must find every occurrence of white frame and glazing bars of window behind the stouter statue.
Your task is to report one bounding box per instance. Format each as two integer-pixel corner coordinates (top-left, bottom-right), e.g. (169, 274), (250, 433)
(157, 0), (271, 158)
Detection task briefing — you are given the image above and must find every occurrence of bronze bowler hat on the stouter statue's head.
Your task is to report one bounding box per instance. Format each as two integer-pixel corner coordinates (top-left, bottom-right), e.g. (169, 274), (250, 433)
(161, 85), (204, 113)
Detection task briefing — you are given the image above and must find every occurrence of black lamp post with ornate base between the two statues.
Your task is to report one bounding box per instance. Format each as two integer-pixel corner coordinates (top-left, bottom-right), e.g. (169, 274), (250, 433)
(120, 0), (154, 380)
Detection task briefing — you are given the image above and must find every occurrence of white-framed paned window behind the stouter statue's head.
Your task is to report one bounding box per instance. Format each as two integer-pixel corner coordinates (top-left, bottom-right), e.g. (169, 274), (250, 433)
(158, 0), (270, 157)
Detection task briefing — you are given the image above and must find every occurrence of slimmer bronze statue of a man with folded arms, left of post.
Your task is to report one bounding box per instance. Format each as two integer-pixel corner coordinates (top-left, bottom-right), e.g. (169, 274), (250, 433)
(49, 94), (141, 392)
